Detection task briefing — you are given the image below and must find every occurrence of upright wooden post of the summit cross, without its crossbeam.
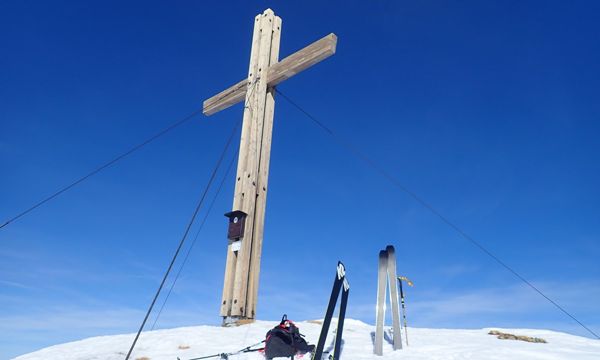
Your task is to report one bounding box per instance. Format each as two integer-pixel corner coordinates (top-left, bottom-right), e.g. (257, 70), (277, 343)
(221, 9), (281, 321)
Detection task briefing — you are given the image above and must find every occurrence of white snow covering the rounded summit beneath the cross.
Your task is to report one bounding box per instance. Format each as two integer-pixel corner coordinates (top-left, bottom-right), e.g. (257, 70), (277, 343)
(15, 319), (600, 360)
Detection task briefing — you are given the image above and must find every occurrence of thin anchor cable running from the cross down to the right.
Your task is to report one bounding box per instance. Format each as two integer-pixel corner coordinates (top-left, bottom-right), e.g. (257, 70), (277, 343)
(275, 88), (600, 339)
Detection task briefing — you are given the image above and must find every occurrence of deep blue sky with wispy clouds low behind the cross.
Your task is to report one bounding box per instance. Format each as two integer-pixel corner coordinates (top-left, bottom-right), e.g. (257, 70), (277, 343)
(0, 1), (600, 358)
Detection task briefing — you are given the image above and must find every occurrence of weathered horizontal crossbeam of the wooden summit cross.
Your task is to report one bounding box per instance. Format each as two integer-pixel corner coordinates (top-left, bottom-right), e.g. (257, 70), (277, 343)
(202, 33), (337, 116)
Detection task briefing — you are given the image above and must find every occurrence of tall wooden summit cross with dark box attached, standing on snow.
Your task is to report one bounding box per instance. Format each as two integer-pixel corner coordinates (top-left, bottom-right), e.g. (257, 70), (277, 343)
(203, 9), (337, 325)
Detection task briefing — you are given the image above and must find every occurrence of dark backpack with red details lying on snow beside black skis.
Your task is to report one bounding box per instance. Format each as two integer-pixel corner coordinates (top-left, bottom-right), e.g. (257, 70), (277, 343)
(265, 314), (315, 360)
